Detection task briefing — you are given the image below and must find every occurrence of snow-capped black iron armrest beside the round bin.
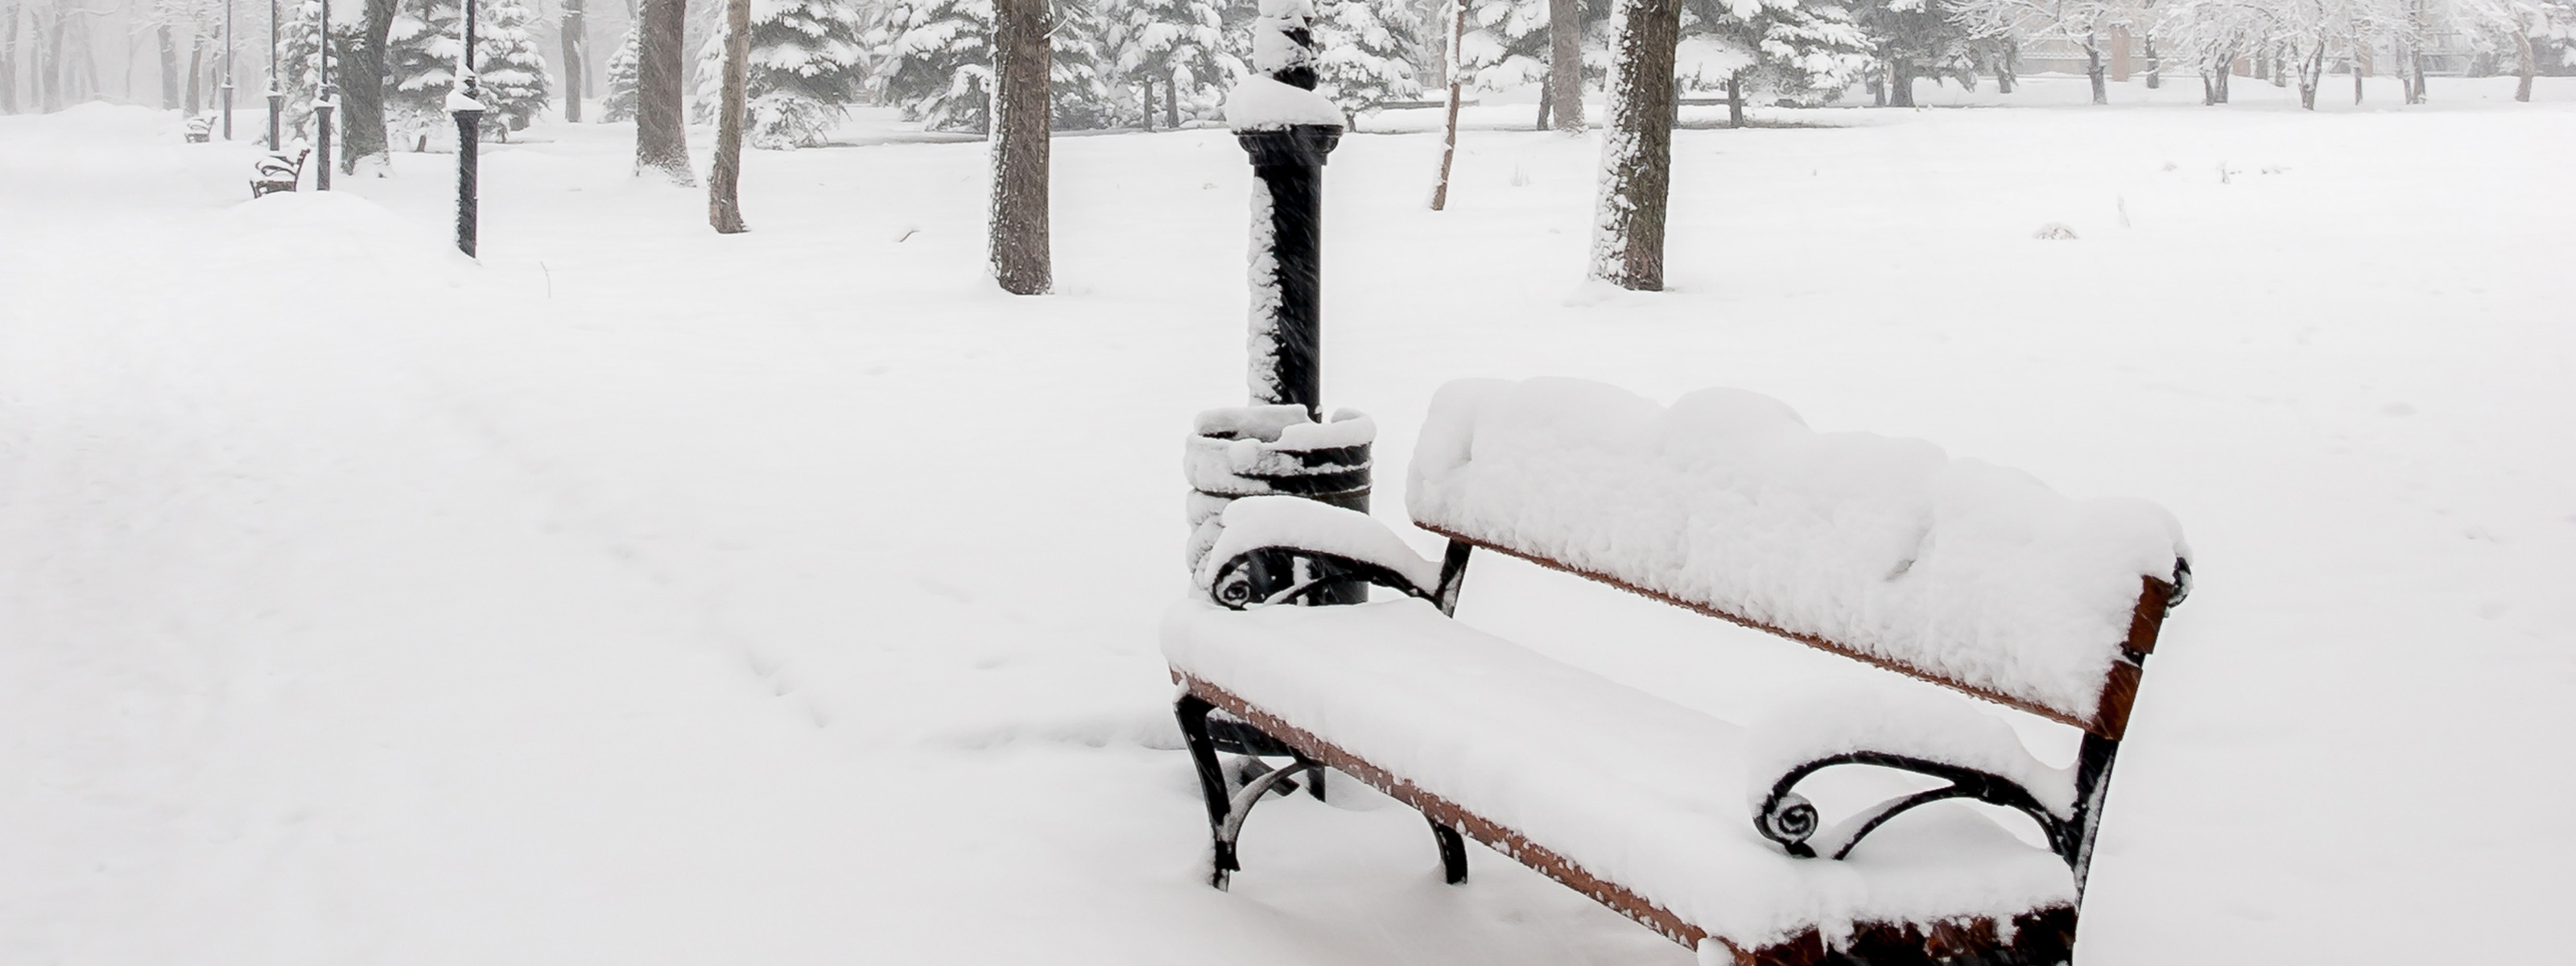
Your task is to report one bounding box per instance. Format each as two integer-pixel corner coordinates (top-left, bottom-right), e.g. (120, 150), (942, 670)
(1195, 497), (1443, 610)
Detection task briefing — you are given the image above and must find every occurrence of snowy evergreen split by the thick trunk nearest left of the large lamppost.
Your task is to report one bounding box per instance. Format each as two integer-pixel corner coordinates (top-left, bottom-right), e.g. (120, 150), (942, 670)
(868, 0), (1110, 134)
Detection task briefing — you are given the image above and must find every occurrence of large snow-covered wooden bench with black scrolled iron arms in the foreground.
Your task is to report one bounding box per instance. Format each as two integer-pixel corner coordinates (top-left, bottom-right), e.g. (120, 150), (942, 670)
(1162, 378), (2190, 964)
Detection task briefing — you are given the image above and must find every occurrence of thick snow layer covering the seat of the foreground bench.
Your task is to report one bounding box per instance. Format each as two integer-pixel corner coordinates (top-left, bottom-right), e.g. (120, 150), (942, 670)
(1162, 597), (2074, 948)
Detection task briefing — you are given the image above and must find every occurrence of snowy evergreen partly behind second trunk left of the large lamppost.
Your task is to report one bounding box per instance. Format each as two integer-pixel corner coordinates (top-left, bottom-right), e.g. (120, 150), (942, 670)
(698, 0), (868, 150)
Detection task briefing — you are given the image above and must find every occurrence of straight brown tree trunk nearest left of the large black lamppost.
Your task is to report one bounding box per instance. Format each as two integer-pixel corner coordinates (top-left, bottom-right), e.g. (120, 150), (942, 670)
(992, 0), (1056, 296)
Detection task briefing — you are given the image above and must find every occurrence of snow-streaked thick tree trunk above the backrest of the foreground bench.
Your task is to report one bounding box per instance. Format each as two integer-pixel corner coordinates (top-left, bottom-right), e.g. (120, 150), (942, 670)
(1592, 0), (1682, 291)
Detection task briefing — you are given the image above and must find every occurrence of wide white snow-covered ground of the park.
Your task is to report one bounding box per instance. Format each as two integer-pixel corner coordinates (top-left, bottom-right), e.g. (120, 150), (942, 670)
(0, 77), (2576, 966)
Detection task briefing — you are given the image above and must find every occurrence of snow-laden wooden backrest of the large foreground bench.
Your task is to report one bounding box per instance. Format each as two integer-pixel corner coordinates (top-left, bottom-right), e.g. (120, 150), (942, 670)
(1406, 378), (2190, 739)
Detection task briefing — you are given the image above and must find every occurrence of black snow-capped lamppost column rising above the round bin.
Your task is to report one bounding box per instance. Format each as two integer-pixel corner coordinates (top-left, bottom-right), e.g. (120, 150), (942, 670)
(1226, 0), (1348, 420)
